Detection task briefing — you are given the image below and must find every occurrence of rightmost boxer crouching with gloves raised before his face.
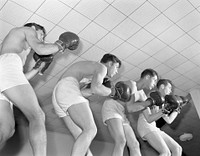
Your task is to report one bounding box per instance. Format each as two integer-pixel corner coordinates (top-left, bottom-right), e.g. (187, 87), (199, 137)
(137, 79), (184, 156)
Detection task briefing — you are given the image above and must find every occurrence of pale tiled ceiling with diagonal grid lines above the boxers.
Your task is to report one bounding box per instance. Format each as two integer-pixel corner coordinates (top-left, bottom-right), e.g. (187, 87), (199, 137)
(0, 0), (200, 155)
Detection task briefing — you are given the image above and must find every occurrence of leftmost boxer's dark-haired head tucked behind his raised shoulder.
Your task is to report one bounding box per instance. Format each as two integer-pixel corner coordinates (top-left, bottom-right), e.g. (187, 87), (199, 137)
(24, 23), (46, 41)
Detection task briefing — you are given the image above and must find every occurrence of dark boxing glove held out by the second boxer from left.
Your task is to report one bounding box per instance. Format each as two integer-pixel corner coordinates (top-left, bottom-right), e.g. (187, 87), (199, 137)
(110, 81), (132, 102)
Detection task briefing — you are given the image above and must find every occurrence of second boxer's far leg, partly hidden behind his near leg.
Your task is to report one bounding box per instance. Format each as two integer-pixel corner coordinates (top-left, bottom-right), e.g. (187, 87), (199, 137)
(62, 115), (93, 156)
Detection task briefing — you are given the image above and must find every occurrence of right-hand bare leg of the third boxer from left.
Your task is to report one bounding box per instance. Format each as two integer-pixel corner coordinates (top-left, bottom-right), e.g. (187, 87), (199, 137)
(124, 124), (141, 156)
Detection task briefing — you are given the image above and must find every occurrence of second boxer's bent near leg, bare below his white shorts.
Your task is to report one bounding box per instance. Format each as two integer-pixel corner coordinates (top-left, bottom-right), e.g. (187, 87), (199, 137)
(68, 103), (97, 156)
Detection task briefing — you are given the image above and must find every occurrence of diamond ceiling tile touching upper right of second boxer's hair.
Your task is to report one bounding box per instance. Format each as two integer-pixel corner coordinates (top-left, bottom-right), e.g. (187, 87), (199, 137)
(112, 42), (137, 59)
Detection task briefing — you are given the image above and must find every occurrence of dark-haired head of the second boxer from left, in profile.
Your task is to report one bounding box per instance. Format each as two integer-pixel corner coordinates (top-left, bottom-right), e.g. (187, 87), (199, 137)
(100, 54), (121, 77)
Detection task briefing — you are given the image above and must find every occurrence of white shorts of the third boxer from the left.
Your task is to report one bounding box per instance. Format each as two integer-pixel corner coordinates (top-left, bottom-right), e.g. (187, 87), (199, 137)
(102, 99), (129, 125)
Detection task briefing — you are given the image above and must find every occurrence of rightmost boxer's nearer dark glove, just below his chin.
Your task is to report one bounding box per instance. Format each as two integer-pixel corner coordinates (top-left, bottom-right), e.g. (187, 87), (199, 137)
(164, 95), (181, 112)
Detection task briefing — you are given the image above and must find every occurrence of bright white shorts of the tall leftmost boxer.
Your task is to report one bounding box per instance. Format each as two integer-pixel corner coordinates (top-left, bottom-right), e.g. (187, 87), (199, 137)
(0, 53), (29, 92)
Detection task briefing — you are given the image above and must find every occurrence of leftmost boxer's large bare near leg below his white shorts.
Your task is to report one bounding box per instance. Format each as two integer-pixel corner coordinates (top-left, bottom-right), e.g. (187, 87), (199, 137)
(3, 84), (47, 156)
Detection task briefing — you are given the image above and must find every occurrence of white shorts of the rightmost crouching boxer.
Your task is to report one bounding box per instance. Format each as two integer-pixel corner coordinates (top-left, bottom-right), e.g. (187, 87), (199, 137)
(137, 113), (161, 140)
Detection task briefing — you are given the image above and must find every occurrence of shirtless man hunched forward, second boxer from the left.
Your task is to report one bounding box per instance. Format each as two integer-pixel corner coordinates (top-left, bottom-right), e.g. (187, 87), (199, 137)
(52, 54), (121, 156)
